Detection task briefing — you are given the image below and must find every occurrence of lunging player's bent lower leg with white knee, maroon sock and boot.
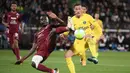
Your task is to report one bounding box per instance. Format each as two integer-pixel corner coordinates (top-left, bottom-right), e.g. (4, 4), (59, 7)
(32, 55), (59, 73)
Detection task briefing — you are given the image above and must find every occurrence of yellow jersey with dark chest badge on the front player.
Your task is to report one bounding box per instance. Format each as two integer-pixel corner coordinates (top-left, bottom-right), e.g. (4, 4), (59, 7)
(72, 13), (102, 36)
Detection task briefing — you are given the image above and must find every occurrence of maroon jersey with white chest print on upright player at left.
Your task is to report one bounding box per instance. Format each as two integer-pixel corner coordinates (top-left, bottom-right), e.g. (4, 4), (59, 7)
(4, 12), (21, 33)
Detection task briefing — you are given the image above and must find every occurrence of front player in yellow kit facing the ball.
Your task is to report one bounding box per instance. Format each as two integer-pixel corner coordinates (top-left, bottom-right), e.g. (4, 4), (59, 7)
(65, 4), (102, 73)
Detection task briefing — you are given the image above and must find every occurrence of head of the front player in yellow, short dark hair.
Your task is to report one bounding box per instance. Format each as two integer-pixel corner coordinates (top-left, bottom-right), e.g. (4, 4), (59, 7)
(73, 3), (83, 17)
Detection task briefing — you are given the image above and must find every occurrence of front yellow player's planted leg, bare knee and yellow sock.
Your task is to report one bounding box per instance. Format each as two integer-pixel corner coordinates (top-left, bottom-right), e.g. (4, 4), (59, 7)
(65, 50), (76, 73)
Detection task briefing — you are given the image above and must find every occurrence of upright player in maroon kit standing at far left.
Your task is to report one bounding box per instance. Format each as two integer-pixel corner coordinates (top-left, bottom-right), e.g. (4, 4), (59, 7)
(2, 2), (23, 60)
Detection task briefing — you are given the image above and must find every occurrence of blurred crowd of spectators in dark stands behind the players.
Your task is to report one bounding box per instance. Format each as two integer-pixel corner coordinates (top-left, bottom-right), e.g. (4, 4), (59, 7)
(0, 0), (130, 50)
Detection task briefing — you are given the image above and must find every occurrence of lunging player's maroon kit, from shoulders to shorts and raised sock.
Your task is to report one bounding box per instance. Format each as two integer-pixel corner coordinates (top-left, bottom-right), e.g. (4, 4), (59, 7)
(35, 25), (67, 58)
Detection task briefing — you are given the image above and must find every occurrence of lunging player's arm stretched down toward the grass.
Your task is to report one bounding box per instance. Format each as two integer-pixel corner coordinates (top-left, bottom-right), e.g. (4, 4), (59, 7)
(15, 43), (37, 65)
